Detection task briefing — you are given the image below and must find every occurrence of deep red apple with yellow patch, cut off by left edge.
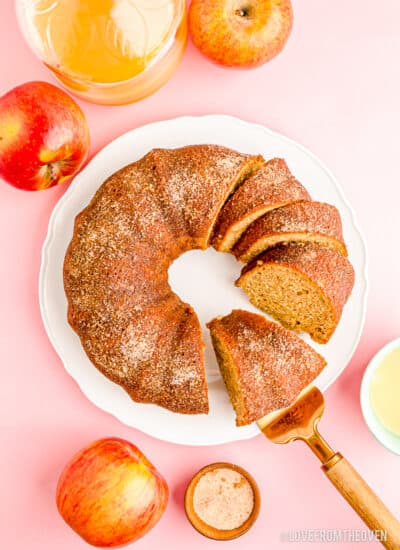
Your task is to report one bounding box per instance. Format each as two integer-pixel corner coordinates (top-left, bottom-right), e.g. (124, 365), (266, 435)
(0, 82), (90, 191)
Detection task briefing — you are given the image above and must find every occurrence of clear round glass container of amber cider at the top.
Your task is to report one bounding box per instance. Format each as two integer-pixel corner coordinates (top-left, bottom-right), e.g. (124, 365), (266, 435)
(16, 0), (187, 105)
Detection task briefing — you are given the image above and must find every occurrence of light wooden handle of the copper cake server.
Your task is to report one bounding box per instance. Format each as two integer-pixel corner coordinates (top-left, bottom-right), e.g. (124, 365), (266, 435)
(322, 453), (400, 550)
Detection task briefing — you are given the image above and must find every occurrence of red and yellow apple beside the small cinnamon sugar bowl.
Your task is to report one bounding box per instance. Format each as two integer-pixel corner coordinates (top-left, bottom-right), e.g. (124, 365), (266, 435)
(56, 438), (168, 548)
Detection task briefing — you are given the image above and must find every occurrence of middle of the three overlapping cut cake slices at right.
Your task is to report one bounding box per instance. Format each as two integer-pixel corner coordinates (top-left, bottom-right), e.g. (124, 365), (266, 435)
(233, 201), (347, 263)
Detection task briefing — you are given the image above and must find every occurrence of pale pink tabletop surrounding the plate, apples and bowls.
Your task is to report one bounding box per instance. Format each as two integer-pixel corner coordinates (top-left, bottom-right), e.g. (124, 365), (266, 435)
(0, 0), (400, 550)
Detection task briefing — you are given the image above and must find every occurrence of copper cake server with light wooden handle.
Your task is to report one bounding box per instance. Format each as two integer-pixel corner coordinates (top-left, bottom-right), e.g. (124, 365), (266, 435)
(257, 387), (400, 550)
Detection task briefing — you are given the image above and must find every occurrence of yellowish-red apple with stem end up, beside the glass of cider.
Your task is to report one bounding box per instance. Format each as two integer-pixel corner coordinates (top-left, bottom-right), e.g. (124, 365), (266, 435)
(189, 0), (293, 69)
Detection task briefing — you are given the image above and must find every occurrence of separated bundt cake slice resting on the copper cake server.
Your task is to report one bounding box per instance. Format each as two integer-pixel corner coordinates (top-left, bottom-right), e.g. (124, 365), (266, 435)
(207, 310), (326, 426)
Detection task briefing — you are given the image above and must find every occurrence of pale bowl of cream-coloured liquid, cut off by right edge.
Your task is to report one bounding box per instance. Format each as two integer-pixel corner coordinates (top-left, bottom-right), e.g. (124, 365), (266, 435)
(360, 338), (400, 454)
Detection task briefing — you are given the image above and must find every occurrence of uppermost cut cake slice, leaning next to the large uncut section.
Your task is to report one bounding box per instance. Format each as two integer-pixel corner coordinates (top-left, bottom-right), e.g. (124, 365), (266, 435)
(211, 158), (310, 252)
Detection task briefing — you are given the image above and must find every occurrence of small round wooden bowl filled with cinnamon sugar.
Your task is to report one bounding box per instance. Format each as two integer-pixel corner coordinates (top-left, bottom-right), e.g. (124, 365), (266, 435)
(185, 462), (260, 540)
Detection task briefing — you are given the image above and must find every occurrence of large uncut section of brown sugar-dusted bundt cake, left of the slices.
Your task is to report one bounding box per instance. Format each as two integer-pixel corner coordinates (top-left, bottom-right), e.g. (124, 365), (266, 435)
(64, 145), (264, 414)
